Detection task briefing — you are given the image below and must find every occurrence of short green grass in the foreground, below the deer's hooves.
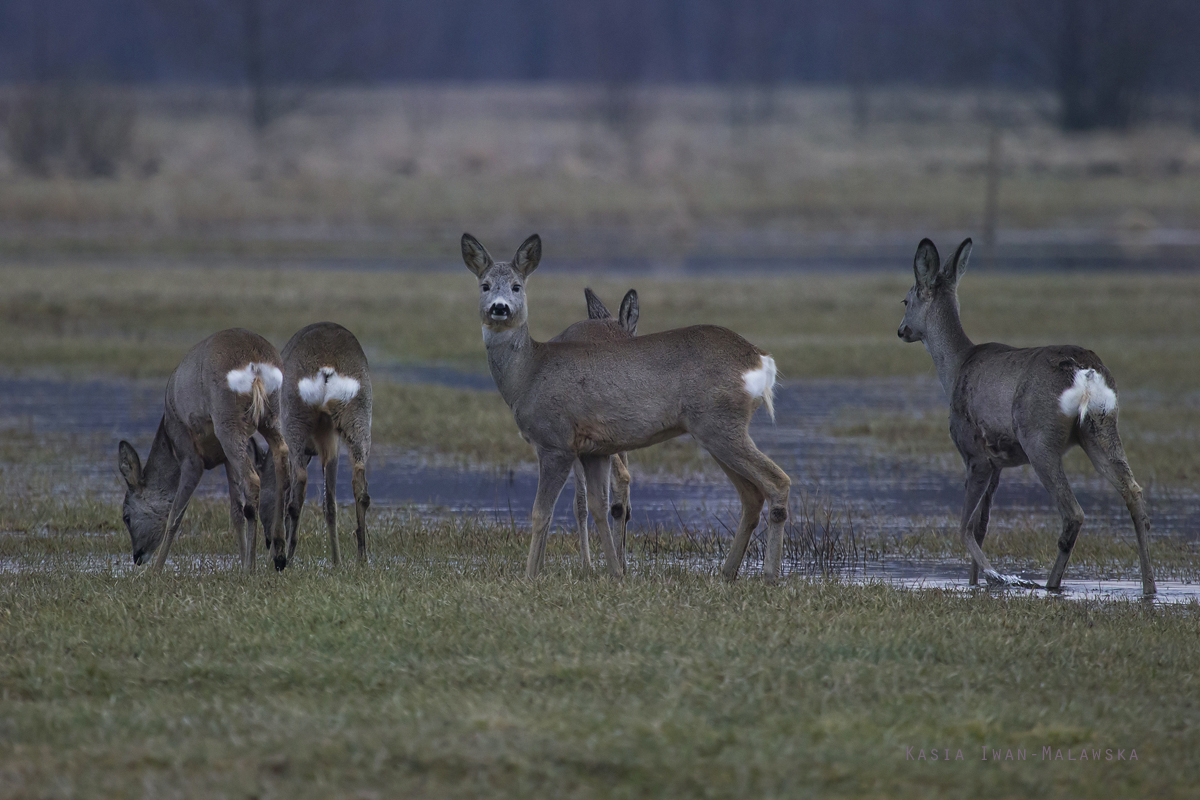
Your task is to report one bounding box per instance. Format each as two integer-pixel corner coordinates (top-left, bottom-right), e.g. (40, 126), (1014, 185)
(0, 503), (1200, 798)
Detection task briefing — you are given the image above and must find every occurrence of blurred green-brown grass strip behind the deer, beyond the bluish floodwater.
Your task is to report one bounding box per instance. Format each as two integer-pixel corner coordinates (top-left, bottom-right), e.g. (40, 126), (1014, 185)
(0, 260), (1200, 483)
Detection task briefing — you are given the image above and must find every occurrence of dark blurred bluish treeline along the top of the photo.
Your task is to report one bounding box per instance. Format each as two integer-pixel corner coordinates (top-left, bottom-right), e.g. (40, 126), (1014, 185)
(0, 0), (1200, 130)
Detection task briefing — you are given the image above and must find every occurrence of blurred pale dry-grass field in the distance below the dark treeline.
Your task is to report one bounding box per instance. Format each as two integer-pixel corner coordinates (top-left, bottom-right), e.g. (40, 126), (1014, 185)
(0, 85), (1200, 258)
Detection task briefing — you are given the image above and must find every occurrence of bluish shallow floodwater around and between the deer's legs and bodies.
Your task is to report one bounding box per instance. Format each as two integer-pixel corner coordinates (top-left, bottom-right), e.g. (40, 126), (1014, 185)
(0, 365), (1200, 599)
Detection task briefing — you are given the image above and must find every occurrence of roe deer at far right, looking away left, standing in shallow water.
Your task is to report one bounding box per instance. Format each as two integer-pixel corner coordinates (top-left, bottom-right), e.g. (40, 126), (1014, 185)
(896, 239), (1156, 595)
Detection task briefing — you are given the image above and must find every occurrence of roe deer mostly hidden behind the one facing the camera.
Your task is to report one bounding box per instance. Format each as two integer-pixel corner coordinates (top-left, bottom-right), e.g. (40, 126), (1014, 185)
(550, 289), (638, 569)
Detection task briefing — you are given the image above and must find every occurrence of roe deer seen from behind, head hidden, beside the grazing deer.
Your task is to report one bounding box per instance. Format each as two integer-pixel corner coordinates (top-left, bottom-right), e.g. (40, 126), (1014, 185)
(259, 323), (371, 565)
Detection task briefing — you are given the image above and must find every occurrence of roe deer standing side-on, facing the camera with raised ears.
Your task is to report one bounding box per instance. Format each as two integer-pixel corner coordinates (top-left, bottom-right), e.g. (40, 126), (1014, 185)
(462, 234), (791, 581)
